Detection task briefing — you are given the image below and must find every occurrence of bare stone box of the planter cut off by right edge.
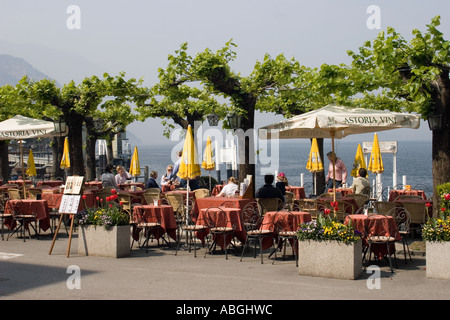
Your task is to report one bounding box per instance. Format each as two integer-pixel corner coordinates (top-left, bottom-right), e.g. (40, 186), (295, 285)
(425, 241), (450, 280)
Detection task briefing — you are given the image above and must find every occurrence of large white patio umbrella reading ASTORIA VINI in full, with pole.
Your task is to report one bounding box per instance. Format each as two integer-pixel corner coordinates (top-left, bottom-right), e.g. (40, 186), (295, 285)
(258, 105), (420, 200)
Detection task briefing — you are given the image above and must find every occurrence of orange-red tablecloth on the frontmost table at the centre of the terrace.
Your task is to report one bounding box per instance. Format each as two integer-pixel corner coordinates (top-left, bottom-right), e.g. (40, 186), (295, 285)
(196, 207), (246, 249)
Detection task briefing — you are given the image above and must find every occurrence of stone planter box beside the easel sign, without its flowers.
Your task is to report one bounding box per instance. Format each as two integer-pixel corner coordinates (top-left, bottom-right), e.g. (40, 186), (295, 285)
(78, 225), (131, 258)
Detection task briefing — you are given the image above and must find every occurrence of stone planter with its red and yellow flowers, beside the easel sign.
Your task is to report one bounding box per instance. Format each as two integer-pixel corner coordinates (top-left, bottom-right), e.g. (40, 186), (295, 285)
(75, 190), (131, 258)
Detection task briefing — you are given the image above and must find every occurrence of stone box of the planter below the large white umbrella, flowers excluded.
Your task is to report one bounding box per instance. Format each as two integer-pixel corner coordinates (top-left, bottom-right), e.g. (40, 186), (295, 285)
(298, 240), (362, 280)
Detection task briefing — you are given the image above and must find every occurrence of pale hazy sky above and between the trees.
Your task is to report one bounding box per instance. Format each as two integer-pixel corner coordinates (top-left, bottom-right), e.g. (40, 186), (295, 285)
(0, 0), (450, 145)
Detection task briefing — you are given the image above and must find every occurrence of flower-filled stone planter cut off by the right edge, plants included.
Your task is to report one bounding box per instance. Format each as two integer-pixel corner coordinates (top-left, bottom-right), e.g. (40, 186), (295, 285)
(422, 183), (450, 280)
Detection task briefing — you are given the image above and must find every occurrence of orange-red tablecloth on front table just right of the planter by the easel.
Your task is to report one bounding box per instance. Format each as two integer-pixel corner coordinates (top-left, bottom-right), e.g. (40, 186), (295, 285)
(132, 204), (177, 241)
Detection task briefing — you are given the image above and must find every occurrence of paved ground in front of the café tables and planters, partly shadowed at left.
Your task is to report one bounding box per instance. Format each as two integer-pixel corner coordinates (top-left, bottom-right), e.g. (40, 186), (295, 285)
(0, 226), (450, 311)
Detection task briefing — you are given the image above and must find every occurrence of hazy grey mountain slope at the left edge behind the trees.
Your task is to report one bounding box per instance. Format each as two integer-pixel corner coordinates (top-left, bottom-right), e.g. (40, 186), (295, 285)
(0, 54), (58, 86)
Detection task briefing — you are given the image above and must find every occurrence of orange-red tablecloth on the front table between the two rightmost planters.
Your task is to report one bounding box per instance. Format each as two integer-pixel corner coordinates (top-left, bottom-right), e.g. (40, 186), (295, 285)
(344, 214), (402, 259)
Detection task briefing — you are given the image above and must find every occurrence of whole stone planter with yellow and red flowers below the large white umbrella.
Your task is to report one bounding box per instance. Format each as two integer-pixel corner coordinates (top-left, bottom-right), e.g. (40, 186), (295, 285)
(297, 209), (362, 280)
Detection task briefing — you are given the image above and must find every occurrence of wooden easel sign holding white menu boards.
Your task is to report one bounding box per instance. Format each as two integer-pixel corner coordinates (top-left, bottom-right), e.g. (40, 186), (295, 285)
(48, 176), (84, 257)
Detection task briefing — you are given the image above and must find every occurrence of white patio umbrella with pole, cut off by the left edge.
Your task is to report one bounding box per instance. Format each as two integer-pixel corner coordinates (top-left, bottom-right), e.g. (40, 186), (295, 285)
(0, 115), (65, 194)
